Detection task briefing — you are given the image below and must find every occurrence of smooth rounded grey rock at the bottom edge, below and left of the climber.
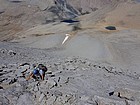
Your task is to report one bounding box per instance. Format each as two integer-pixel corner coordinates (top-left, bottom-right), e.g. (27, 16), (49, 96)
(17, 93), (34, 105)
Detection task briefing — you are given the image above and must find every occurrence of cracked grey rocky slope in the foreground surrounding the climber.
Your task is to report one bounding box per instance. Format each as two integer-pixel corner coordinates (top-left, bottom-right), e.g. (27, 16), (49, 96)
(0, 44), (140, 105)
